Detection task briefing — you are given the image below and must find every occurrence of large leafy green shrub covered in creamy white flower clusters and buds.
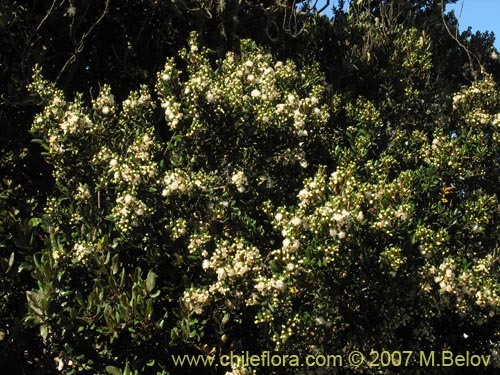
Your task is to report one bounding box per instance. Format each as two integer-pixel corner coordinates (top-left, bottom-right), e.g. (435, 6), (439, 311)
(28, 30), (500, 374)
